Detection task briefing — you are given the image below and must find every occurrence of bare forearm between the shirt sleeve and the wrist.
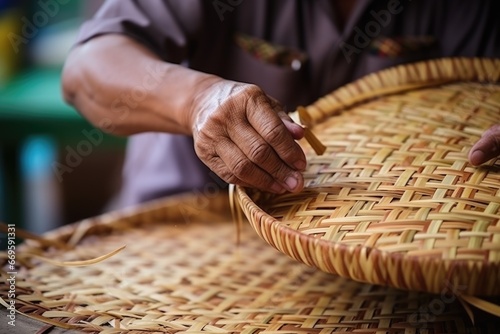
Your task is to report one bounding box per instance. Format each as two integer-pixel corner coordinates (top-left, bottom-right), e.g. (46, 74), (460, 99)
(62, 35), (221, 135)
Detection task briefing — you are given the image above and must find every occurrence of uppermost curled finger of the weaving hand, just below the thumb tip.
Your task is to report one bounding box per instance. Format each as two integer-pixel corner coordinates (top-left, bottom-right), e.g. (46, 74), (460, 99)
(246, 94), (306, 174)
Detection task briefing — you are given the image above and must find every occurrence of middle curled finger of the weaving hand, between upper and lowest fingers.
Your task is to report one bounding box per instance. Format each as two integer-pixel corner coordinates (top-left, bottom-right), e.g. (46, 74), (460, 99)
(229, 117), (303, 192)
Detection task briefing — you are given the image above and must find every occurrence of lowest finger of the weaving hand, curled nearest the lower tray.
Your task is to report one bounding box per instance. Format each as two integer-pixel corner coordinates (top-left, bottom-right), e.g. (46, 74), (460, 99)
(214, 138), (285, 193)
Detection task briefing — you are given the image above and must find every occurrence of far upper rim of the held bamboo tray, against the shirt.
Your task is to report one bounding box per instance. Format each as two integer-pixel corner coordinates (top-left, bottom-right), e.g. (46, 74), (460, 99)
(306, 57), (500, 126)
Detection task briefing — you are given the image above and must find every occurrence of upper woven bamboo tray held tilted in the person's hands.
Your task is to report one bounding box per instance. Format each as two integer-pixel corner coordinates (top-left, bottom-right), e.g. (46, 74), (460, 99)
(236, 58), (500, 296)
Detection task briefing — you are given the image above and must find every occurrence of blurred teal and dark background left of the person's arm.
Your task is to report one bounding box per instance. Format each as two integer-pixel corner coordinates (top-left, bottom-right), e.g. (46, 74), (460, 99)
(0, 0), (125, 239)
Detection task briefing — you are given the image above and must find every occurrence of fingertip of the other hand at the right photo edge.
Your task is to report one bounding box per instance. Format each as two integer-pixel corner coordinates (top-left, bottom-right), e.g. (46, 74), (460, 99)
(469, 124), (500, 166)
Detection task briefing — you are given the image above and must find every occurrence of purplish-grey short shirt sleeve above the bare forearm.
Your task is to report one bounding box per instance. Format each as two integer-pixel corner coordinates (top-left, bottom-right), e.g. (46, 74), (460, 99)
(76, 0), (205, 63)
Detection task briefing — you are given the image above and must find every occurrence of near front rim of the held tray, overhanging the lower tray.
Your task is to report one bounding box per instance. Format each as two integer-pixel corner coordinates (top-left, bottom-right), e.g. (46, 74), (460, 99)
(235, 187), (500, 296)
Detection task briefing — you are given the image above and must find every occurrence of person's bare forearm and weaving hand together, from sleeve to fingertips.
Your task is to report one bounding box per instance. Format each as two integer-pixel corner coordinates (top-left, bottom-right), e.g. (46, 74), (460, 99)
(63, 35), (306, 193)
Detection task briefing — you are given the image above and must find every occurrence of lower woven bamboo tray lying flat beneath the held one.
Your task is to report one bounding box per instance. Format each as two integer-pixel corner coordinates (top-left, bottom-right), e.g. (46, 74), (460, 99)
(0, 194), (496, 334)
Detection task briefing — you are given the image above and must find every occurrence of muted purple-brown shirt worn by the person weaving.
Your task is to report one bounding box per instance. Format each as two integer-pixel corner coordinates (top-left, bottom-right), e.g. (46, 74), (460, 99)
(74, 0), (500, 206)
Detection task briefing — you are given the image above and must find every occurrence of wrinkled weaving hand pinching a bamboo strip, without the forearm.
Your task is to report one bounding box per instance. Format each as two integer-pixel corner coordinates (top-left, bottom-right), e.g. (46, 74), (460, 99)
(190, 80), (306, 193)
